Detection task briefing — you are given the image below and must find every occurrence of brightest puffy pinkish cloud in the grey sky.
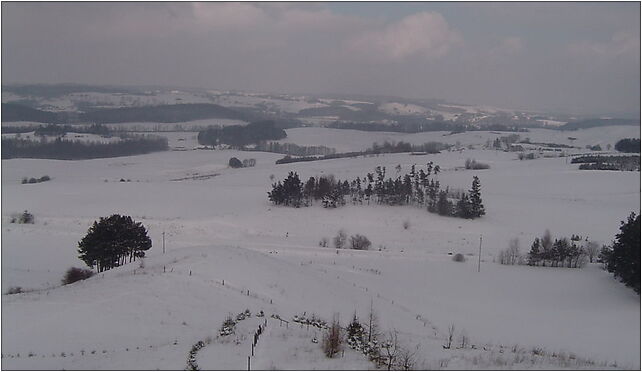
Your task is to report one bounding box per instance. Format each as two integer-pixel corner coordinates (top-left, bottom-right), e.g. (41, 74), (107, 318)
(346, 12), (462, 61)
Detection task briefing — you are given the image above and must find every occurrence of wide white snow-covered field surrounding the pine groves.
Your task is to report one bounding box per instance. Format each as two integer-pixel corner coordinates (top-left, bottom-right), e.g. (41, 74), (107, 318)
(2, 127), (640, 370)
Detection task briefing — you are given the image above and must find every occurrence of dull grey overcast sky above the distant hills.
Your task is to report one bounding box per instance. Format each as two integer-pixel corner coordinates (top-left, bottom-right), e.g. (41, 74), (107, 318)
(2, 2), (640, 114)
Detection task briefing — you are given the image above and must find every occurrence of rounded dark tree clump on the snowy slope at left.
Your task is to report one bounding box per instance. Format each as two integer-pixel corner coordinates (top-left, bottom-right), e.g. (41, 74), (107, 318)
(78, 214), (152, 272)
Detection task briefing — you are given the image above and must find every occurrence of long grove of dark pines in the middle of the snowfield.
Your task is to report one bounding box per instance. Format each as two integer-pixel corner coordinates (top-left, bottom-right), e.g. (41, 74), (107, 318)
(268, 162), (486, 218)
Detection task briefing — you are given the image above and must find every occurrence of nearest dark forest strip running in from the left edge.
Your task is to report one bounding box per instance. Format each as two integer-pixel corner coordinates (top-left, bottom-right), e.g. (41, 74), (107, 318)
(2, 136), (169, 160)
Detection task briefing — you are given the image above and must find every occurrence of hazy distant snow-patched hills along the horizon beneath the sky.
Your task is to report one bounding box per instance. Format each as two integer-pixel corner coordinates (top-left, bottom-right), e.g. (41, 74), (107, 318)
(2, 84), (592, 127)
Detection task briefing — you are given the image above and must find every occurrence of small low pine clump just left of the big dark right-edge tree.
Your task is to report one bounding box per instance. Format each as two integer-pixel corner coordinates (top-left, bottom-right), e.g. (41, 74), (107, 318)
(527, 230), (587, 268)
